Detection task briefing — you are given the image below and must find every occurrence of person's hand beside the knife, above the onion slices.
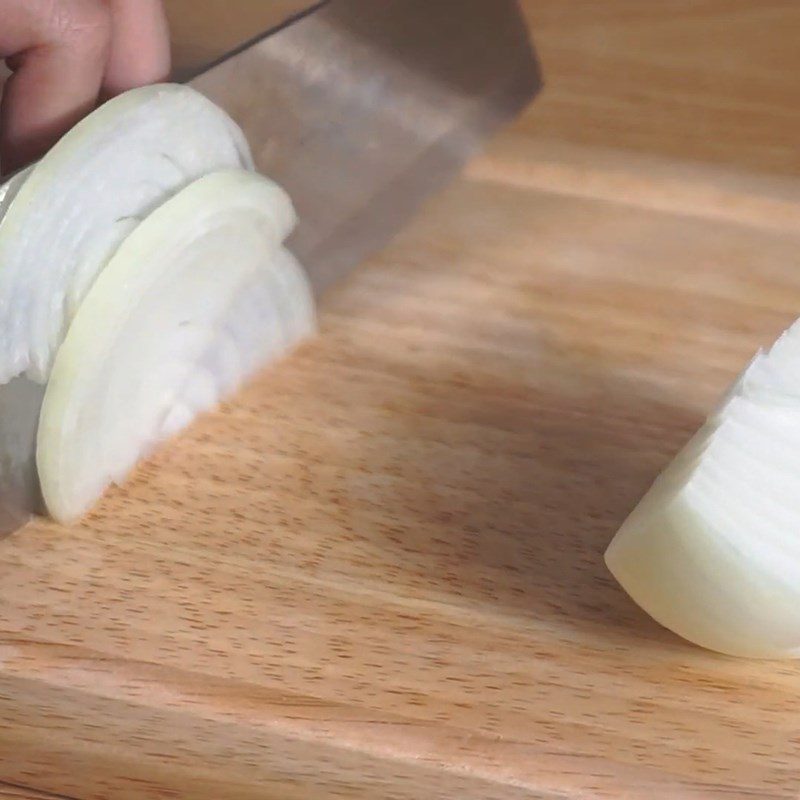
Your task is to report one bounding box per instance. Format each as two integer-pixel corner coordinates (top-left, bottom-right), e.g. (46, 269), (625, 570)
(0, 0), (170, 173)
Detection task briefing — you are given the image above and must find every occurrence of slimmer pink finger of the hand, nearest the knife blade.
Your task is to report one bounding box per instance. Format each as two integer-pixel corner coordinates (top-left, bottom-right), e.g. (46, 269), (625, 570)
(103, 0), (170, 94)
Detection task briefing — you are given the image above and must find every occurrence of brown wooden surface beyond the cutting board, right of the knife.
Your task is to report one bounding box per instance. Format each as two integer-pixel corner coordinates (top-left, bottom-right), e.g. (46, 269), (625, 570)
(522, 0), (800, 176)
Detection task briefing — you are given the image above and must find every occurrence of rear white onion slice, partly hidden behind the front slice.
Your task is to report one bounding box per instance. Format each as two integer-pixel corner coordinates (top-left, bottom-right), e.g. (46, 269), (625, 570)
(0, 84), (252, 383)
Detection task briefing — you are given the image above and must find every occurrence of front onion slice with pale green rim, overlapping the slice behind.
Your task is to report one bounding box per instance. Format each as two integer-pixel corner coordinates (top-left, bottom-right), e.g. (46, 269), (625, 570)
(37, 170), (314, 522)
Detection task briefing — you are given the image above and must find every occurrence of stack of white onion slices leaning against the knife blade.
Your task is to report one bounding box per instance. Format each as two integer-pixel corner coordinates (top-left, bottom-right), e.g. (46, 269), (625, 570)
(0, 85), (315, 522)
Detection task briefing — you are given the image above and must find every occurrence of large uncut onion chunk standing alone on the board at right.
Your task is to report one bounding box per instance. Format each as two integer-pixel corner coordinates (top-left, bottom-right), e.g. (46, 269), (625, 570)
(605, 321), (800, 658)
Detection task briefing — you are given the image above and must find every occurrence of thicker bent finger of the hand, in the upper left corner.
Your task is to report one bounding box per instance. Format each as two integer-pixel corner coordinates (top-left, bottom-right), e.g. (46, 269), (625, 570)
(0, 0), (112, 172)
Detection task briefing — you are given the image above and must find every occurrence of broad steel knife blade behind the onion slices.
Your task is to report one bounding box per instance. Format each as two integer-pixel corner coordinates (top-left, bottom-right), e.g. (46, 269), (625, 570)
(0, 0), (540, 534)
